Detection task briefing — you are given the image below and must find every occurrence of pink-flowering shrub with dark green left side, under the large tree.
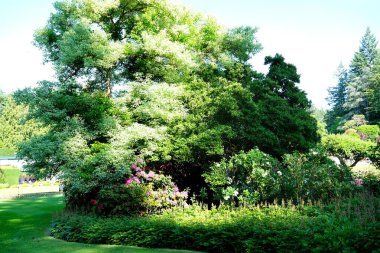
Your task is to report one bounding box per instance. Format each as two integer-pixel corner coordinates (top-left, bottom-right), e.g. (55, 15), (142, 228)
(91, 159), (188, 215)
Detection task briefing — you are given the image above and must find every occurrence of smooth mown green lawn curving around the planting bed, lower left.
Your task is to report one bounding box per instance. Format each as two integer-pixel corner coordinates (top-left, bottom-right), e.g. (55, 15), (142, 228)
(0, 194), (200, 253)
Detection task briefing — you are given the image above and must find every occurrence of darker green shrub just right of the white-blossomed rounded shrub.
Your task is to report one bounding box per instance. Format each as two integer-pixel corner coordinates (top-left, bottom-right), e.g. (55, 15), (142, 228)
(280, 150), (351, 203)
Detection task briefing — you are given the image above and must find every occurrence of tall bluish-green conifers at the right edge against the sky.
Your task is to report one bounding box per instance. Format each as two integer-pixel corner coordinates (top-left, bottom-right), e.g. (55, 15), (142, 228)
(326, 28), (380, 133)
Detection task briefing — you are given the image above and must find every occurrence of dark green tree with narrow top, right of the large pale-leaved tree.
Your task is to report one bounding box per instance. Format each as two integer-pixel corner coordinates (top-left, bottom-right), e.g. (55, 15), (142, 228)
(248, 54), (319, 158)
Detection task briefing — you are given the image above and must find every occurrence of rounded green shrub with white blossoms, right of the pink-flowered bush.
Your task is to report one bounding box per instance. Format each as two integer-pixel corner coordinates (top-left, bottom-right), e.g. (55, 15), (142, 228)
(204, 149), (281, 205)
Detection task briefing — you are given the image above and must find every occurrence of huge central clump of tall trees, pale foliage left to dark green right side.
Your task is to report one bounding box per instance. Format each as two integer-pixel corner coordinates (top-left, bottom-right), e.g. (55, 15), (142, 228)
(16, 0), (318, 210)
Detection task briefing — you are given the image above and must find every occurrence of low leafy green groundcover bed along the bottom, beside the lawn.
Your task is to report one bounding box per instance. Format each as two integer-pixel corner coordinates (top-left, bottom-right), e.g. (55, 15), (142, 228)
(51, 202), (380, 252)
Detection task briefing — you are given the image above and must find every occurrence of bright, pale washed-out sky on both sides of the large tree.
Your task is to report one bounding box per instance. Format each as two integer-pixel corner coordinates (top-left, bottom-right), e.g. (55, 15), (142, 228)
(0, 0), (380, 107)
